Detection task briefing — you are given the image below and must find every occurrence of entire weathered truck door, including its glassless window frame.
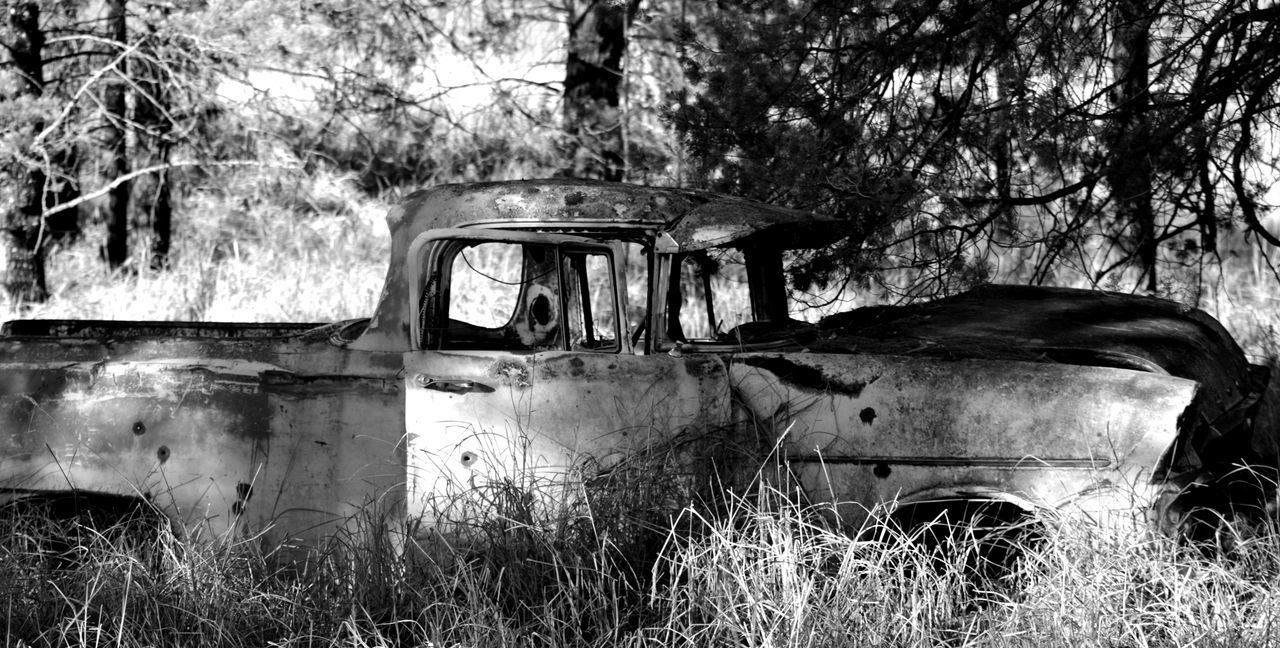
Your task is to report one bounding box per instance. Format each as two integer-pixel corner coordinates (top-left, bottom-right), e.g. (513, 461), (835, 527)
(404, 229), (728, 524)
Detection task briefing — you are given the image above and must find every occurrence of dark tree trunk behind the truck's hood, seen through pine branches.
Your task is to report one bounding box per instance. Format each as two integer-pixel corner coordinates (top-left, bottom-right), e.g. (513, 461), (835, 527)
(1107, 0), (1158, 292)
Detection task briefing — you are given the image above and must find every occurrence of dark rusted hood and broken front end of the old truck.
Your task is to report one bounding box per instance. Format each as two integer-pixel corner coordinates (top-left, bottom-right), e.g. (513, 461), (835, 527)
(812, 286), (1277, 464)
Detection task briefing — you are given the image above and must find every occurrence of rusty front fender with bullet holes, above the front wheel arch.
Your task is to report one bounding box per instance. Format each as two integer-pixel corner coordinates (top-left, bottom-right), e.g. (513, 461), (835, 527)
(730, 353), (1197, 520)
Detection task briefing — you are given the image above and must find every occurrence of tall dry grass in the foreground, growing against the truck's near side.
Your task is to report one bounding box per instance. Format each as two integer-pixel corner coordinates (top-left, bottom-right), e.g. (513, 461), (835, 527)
(0, 475), (1280, 648)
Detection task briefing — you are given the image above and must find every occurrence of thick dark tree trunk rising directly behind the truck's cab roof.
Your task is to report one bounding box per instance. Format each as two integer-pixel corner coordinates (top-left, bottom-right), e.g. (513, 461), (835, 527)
(564, 0), (640, 182)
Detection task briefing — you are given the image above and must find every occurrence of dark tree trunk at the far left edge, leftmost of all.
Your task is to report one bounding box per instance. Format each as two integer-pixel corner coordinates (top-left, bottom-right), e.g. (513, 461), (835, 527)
(0, 3), (49, 304)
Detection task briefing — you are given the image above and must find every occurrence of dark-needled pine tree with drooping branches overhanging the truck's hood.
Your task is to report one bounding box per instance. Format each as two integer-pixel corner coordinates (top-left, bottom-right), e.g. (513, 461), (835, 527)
(675, 0), (1280, 295)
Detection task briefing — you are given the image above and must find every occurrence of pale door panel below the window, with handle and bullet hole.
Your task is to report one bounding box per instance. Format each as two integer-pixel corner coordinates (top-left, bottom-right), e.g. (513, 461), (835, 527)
(404, 351), (730, 522)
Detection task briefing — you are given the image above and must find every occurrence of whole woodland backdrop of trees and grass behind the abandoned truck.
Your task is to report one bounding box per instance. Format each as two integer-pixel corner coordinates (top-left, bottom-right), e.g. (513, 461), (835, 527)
(0, 0), (1280, 357)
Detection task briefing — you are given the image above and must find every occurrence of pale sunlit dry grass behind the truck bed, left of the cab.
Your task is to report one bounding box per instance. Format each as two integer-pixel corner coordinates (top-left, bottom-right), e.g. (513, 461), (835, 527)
(0, 172), (390, 321)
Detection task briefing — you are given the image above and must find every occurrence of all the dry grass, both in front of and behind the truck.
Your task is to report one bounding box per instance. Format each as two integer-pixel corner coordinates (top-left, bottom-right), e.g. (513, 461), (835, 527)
(0, 175), (1280, 648)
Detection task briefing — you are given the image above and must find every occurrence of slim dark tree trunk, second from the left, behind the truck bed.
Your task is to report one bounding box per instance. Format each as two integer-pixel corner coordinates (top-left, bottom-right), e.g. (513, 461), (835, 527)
(102, 0), (132, 268)
